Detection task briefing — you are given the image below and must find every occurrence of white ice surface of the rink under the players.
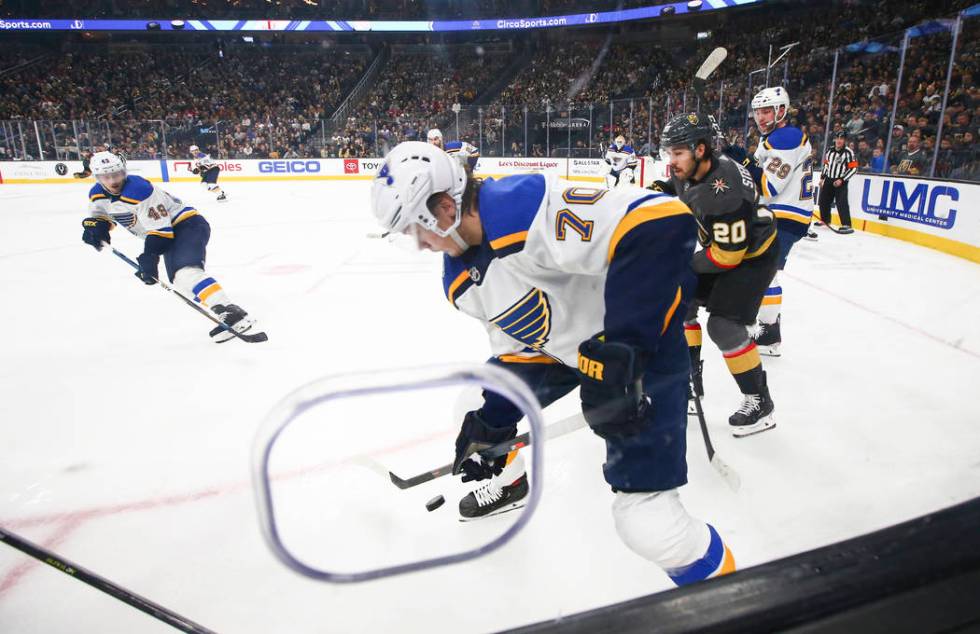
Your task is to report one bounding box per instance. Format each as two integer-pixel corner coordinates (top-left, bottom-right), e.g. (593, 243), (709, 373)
(0, 182), (980, 634)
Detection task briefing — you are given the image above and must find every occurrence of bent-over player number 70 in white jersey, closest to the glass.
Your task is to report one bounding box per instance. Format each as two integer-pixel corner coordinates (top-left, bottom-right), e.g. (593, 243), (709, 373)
(372, 142), (735, 585)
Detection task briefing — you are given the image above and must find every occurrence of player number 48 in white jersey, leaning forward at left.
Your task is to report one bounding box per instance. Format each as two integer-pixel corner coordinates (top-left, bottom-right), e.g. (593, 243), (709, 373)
(82, 152), (259, 343)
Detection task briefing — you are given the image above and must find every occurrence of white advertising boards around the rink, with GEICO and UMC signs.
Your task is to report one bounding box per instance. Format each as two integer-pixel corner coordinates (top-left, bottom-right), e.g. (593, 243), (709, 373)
(0, 157), (980, 262)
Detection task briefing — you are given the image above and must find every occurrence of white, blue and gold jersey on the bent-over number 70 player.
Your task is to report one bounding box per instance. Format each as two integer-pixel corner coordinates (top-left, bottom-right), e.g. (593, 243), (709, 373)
(443, 174), (694, 367)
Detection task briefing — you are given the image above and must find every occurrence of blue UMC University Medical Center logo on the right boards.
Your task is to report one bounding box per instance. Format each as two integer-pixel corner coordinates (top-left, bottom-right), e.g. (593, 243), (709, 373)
(861, 178), (960, 229)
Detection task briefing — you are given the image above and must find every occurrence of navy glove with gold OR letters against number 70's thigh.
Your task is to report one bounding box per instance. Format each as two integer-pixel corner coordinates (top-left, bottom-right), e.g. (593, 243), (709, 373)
(578, 335), (651, 440)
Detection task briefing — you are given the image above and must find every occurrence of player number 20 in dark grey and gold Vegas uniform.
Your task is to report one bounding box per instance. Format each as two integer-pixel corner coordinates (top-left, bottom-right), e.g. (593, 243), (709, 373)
(654, 112), (778, 437)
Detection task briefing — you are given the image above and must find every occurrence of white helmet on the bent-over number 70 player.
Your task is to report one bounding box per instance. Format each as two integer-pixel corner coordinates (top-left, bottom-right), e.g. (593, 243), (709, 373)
(371, 141), (466, 237)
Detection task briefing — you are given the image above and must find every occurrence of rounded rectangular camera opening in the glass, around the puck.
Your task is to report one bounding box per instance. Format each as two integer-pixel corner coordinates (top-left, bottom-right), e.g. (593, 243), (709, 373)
(253, 366), (541, 582)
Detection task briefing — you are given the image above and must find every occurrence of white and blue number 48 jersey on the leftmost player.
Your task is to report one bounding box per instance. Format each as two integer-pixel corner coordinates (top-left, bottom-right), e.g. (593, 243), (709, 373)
(88, 176), (198, 238)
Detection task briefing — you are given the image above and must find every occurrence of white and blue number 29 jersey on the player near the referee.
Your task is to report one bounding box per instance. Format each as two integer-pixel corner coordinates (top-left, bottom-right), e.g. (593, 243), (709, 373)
(755, 126), (813, 227)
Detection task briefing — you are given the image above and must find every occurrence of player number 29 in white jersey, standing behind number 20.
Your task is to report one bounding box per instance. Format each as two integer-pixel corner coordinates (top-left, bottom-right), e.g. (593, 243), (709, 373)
(752, 87), (813, 357)
